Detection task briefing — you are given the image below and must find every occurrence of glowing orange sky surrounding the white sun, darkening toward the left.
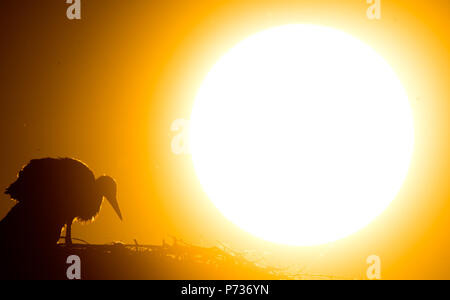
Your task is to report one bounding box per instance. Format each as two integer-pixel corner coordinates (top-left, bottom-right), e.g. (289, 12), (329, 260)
(0, 0), (450, 278)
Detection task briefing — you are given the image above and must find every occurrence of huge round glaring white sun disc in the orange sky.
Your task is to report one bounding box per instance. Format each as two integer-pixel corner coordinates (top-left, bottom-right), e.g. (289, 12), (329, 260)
(190, 24), (414, 246)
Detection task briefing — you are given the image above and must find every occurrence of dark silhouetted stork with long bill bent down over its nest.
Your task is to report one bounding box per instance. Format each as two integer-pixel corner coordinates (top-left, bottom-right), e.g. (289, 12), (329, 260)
(0, 158), (122, 247)
